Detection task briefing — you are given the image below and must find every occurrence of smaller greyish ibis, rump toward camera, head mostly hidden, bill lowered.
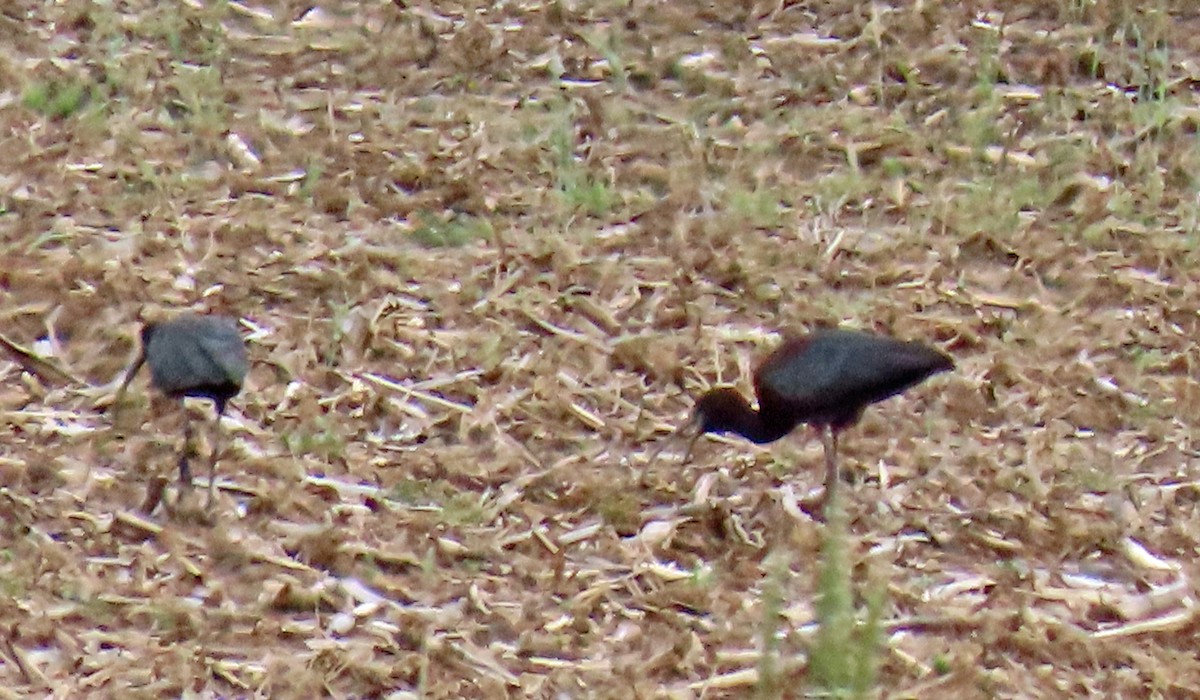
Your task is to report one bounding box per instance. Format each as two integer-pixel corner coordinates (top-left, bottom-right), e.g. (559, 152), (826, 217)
(114, 313), (250, 503)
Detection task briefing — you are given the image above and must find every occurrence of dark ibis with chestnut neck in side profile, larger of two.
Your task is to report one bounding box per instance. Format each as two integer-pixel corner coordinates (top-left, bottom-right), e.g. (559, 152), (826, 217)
(684, 328), (954, 504)
